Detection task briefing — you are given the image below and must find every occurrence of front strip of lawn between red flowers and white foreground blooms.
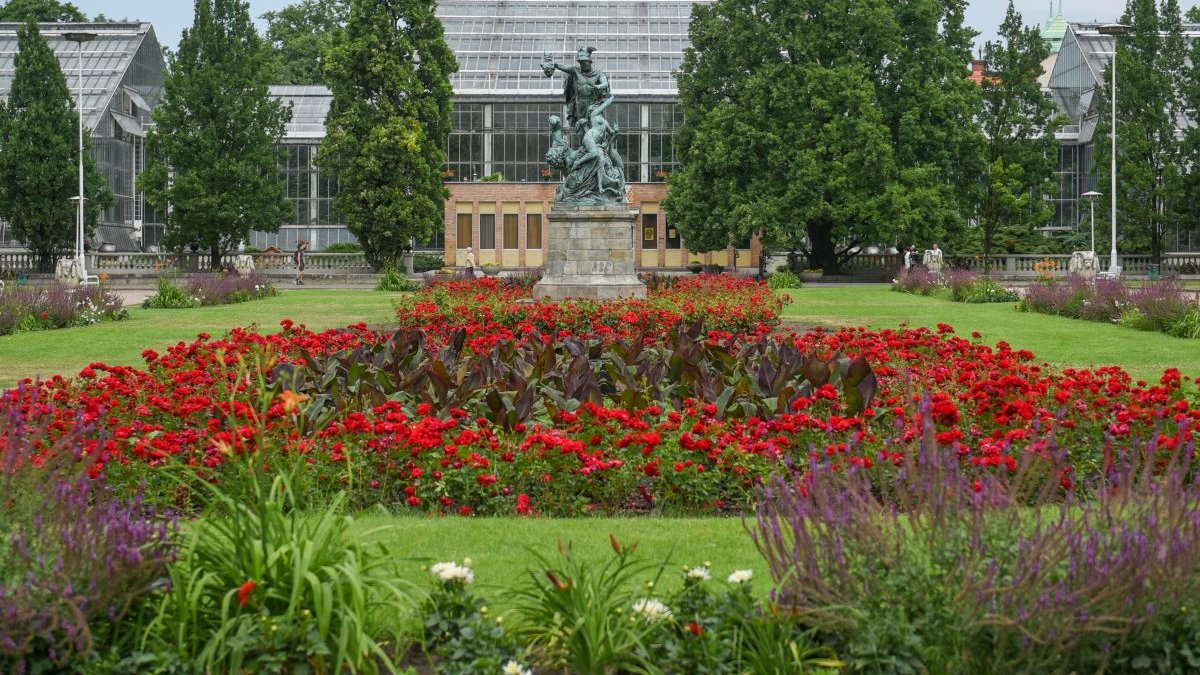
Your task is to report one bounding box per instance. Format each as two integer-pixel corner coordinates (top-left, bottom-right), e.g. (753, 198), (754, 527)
(355, 514), (770, 611)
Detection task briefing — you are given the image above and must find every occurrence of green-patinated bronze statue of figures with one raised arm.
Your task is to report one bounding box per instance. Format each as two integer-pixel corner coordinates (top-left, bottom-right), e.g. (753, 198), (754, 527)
(541, 47), (625, 204)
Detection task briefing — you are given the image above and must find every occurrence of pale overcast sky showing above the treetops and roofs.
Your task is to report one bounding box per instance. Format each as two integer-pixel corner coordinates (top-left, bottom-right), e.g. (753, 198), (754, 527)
(63, 0), (1180, 53)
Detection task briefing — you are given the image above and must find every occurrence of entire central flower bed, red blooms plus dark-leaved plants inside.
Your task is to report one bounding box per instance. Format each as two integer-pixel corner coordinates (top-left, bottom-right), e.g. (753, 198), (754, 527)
(0, 277), (1200, 515)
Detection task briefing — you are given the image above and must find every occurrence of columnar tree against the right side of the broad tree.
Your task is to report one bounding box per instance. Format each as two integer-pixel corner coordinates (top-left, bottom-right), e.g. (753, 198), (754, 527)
(878, 0), (986, 245)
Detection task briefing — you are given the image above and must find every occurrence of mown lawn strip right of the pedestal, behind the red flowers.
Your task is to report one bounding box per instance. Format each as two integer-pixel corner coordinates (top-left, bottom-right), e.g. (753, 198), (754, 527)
(784, 285), (1200, 381)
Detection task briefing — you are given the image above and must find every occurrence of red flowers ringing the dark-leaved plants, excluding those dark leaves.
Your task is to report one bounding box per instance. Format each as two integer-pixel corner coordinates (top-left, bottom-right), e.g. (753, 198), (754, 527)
(0, 277), (1200, 514)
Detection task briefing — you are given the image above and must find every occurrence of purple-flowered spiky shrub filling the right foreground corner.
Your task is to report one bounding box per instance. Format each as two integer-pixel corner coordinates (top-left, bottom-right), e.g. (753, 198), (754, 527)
(754, 391), (1200, 673)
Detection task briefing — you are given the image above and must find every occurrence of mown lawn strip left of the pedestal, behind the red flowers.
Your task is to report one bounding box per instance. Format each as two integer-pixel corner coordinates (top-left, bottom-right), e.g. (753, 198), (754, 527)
(0, 289), (401, 388)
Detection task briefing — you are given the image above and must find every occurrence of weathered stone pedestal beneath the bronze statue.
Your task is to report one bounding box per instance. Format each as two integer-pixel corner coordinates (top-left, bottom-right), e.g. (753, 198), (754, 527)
(533, 204), (646, 300)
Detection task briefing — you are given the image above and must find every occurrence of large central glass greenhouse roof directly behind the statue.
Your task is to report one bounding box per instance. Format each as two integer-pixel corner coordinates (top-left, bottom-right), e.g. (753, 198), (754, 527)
(438, 0), (710, 96)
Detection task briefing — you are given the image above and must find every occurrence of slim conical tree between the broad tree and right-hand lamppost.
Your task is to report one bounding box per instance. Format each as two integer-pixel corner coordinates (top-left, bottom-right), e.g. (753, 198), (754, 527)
(978, 0), (1063, 263)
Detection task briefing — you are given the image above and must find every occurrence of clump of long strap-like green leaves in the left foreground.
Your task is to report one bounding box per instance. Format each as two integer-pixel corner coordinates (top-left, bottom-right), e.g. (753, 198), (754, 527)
(145, 432), (413, 673)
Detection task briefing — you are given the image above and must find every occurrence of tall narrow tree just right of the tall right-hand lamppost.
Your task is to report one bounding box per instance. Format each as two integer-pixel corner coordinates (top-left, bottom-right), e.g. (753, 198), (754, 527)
(1096, 0), (1186, 262)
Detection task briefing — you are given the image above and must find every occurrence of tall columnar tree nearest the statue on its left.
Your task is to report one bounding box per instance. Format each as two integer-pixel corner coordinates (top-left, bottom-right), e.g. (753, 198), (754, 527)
(318, 0), (458, 267)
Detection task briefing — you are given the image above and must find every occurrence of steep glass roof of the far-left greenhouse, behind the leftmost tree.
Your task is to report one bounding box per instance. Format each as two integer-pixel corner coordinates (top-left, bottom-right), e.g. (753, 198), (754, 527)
(0, 23), (151, 129)
